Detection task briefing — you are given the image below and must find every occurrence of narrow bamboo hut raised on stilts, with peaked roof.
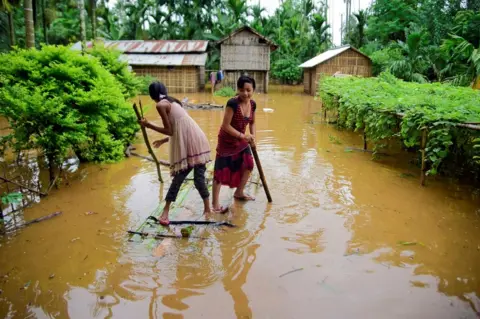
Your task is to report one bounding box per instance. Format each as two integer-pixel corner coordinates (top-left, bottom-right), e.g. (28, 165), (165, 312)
(218, 26), (277, 93)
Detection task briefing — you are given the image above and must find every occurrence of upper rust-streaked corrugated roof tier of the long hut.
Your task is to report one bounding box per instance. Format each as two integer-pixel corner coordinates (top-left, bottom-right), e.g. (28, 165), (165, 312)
(72, 40), (208, 53)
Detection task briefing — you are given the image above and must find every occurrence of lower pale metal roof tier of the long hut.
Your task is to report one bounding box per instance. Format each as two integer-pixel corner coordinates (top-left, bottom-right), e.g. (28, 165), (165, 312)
(120, 53), (207, 66)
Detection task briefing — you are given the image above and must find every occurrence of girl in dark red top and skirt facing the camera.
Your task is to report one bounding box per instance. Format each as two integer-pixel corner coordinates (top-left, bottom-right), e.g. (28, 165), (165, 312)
(212, 76), (257, 212)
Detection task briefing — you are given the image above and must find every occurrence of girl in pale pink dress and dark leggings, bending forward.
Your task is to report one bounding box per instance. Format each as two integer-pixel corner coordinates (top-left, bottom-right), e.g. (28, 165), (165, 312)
(140, 82), (225, 226)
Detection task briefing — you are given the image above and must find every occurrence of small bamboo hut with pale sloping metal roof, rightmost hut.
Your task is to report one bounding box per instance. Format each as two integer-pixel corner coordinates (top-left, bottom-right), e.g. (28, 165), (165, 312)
(300, 45), (372, 95)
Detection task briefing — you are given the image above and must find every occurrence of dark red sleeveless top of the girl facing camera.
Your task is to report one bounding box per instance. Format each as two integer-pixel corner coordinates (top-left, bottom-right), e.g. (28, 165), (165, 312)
(217, 97), (257, 157)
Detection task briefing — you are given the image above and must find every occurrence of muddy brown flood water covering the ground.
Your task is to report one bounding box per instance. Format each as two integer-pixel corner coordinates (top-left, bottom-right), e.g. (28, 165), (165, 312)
(0, 87), (480, 318)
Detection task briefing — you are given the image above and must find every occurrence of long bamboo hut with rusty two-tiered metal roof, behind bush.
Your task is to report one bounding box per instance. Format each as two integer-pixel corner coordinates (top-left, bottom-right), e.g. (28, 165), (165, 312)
(73, 40), (208, 93)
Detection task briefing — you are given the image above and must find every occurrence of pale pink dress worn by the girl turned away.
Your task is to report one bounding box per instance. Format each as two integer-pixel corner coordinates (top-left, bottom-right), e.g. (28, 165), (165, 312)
(165, 102), (210, 175)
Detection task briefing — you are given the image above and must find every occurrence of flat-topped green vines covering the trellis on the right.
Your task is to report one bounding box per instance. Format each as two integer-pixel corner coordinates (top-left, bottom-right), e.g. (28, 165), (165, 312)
(319, 73), (480, 180)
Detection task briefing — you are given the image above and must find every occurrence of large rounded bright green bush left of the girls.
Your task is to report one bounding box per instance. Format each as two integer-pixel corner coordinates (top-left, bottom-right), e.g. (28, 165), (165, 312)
(0, 46), (138, 171)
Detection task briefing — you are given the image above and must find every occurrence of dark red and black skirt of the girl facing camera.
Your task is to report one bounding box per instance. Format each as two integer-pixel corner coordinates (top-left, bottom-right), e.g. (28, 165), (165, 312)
(213, 147), (254, 188)
